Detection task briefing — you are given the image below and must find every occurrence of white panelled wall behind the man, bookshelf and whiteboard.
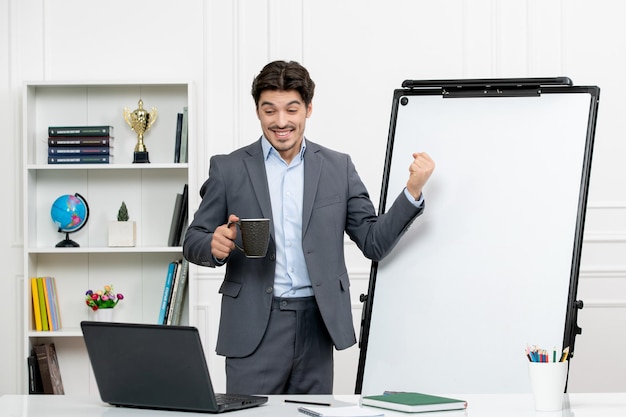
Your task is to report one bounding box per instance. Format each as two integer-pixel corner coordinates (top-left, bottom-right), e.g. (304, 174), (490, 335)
(0, 0), (626, 394)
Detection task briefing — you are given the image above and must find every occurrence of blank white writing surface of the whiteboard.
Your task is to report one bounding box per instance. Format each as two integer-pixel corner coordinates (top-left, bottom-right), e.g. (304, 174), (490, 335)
(361, 85), (595, 395)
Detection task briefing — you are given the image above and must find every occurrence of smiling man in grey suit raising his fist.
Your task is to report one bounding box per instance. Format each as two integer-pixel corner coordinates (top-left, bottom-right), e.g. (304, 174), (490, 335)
(184, 61), (434, 394)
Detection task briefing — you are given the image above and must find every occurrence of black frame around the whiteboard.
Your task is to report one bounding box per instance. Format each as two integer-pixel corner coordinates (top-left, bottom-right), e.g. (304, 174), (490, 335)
(355, 77), (600, 394)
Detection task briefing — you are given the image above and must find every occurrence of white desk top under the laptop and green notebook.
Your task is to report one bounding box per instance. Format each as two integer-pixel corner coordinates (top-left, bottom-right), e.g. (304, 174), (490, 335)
(0, 393), (626, 417)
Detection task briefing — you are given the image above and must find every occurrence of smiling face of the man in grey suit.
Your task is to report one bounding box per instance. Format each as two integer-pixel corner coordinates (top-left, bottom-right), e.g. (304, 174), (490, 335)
(257, 90), (313, 163)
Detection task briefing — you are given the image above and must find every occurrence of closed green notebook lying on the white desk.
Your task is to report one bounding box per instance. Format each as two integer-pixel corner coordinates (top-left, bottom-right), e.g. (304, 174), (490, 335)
(361, 392), (467, 413)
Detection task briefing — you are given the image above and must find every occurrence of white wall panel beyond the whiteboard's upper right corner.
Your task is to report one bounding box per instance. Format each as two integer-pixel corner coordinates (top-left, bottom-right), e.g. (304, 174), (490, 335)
(563, 0), (626, 203)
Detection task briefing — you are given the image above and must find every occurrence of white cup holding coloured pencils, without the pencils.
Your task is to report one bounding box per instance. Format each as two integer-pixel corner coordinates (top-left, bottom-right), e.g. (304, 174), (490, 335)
(528, 361), (567, 411)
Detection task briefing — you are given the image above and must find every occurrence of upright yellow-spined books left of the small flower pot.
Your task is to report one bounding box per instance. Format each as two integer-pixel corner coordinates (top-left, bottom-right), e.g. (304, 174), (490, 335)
(30, 277), (61, 332)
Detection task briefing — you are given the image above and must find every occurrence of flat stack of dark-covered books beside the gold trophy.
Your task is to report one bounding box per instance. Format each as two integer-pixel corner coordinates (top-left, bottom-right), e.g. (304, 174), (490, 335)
(48, 126), (113, 164)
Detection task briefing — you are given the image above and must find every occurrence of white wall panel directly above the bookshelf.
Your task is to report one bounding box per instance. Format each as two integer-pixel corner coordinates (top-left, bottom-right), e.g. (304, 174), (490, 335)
(43, 0), (203, 80)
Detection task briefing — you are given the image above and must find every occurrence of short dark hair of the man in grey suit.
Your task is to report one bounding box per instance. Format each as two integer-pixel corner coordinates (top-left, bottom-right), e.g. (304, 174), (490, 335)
(252, 61), (315, 107)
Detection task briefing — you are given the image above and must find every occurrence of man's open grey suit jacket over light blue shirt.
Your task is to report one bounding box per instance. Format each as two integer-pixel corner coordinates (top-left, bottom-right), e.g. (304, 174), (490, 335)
(184, 140), (423, 357)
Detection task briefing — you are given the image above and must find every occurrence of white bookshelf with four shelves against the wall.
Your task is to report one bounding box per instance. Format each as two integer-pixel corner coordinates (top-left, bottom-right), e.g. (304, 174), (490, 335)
(23, 82), (195, 395)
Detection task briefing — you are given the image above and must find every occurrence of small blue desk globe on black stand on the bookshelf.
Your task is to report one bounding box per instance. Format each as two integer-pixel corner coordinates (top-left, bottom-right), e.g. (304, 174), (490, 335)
(50, 193), (89, 247)
